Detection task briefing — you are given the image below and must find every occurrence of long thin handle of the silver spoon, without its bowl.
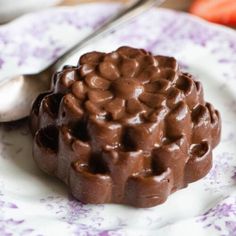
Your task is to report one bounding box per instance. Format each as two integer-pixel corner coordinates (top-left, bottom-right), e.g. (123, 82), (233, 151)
(53, 0), (165, 70)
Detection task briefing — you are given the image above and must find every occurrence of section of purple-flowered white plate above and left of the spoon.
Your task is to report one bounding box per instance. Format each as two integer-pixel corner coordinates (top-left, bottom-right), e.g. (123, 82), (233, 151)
(0, 5), (121, 80)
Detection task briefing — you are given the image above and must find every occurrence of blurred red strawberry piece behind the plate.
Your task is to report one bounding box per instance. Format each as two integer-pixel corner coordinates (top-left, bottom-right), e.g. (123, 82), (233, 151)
(190, 0), (236, 26)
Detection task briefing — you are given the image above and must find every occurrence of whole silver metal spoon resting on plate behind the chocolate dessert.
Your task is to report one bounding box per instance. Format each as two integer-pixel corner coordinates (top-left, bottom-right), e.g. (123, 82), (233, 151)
(0, 0), (164, 122)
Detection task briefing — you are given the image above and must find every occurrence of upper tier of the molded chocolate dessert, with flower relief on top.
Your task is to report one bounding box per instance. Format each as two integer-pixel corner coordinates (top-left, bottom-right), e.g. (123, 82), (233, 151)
(31, 47), (217, 151)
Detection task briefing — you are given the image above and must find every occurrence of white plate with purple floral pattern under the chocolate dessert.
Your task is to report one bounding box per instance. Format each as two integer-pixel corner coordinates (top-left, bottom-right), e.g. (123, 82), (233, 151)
(0, 4), (236, 236)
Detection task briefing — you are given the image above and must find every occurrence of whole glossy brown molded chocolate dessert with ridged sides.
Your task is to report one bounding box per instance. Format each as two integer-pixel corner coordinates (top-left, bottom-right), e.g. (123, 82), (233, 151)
(31, 47), (221, 207)
